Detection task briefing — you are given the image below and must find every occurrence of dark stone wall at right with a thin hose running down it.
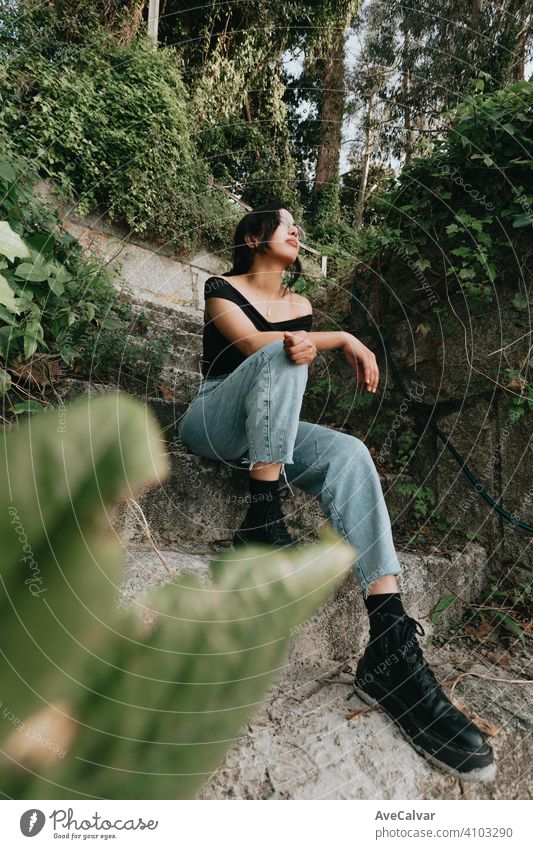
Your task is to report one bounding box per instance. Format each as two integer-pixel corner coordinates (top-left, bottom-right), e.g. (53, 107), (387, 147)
(306, 276), (533, 572)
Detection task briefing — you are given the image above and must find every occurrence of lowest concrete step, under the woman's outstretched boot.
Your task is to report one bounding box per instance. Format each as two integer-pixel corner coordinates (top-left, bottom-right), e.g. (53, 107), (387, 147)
(198, 646), (533, 800)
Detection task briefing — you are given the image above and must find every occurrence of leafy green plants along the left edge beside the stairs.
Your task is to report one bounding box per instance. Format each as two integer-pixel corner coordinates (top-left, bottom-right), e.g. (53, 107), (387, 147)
(0, 146), (170, 415)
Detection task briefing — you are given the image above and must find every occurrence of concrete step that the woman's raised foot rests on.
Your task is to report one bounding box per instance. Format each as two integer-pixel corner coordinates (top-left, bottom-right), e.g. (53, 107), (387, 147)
(115, 540), (487, 664)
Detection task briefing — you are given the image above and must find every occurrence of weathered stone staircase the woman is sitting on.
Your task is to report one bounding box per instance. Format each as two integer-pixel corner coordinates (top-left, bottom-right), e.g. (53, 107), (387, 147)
(51, 300), (531, 799)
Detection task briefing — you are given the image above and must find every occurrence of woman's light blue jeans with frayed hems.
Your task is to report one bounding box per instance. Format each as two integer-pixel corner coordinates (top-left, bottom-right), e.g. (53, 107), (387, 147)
(178, 339), (401, 594)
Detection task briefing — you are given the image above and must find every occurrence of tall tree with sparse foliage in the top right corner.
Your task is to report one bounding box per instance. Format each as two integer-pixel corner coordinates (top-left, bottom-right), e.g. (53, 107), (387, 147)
(347, 0), (533, 171)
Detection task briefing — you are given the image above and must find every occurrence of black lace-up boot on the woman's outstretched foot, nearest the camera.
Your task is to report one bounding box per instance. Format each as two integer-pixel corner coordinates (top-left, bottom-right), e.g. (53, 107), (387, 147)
(349, 613), (496, 781)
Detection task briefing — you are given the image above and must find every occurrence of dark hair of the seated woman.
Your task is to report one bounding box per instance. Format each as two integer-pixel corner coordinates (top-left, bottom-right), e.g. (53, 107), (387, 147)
(225, 200), (302, 289)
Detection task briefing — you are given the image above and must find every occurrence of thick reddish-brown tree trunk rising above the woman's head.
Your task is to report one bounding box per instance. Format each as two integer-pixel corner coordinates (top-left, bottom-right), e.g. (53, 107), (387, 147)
(313, 27), (344, 190)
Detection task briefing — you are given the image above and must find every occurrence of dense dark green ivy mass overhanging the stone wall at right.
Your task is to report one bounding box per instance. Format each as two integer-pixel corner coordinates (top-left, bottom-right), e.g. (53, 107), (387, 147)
(366, 79), (533, 309)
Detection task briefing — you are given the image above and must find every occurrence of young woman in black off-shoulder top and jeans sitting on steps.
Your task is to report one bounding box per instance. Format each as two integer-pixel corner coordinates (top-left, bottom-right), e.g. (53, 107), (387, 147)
(179, 202), (495, 781)
